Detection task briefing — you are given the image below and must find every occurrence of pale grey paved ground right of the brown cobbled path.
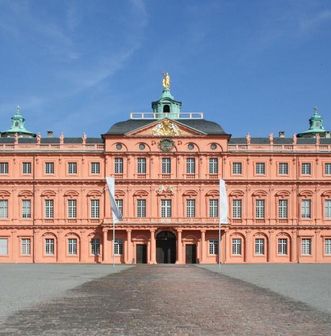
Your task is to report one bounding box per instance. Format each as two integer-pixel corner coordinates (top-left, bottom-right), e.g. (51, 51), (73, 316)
(201, 264), (331, 316)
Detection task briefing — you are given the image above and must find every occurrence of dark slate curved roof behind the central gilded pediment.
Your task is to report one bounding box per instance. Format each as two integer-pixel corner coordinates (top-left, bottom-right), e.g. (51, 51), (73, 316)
(105, 119), (228, 135)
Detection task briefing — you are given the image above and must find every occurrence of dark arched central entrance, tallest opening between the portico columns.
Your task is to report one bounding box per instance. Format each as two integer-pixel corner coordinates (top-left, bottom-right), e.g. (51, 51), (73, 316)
(156, 231), (176, 264)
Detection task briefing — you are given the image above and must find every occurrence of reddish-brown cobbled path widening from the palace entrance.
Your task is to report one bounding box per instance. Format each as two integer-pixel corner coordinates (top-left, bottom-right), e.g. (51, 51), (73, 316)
(0, 265), (331, 336)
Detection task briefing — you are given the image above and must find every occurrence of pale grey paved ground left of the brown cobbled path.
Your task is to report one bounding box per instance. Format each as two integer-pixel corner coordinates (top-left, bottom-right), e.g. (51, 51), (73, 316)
(0, 264), (128, 322)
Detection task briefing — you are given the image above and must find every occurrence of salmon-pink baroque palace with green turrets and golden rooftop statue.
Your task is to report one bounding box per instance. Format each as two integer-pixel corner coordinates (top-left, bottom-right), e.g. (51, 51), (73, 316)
(0, 78), (331, 264)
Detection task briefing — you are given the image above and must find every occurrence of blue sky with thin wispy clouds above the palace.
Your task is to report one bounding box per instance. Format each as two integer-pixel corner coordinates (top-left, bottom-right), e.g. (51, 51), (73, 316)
(0, 0), (331, 136)
